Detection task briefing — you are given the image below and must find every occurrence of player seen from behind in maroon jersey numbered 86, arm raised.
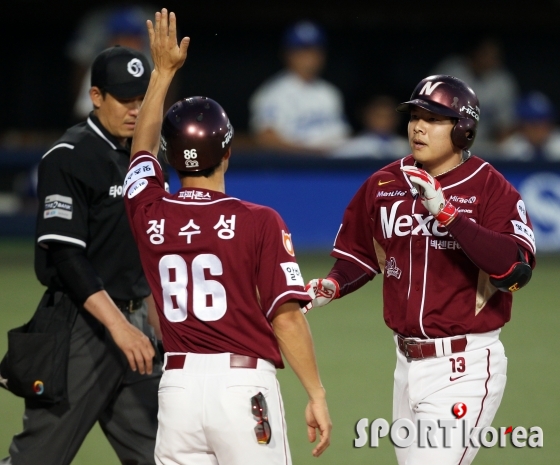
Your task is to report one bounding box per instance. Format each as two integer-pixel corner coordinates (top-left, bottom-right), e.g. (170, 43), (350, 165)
(123, 9), (331, 465)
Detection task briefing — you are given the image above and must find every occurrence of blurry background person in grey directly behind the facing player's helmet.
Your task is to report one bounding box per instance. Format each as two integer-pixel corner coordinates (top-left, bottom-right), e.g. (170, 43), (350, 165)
(432, 37), (518, 154)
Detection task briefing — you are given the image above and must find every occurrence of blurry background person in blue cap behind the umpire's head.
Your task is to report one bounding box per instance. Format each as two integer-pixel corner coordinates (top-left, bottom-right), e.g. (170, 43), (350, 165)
(67, 6), (157, 120)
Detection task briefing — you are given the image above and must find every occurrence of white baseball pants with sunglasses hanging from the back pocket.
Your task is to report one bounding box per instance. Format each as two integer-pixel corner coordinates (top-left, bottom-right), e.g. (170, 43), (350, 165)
(155, 353), (292, 465)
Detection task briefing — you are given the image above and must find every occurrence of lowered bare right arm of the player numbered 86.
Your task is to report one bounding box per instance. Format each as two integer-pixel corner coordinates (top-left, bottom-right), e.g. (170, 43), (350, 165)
(272, 300), (332, 457)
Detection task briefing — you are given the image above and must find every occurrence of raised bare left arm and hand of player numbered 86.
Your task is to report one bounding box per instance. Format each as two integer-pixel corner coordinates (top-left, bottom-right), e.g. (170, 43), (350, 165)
(131, 8), (190, 157)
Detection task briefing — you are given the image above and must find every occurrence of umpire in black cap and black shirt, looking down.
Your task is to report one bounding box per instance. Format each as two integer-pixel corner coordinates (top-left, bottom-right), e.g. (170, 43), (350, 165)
(0, 46), (161, 465)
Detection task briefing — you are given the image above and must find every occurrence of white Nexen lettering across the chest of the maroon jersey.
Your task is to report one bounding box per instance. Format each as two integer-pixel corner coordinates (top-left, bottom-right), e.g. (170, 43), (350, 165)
(379, 200), (448, 239)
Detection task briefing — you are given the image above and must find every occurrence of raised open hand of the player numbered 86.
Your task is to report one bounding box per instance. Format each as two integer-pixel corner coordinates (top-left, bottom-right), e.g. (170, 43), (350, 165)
(146, 8), (190, 73)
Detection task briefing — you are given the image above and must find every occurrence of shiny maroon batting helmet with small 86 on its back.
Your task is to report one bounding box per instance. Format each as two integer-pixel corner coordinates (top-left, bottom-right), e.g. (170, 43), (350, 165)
(161, 97), (233, 172)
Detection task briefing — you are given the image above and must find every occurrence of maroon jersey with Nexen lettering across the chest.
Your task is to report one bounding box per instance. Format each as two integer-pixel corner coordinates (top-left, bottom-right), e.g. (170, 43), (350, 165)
(331, 156), (535, 338)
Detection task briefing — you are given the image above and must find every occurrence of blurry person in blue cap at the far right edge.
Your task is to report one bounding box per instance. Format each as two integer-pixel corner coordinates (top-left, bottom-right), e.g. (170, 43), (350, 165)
(500, 91), (560, 161)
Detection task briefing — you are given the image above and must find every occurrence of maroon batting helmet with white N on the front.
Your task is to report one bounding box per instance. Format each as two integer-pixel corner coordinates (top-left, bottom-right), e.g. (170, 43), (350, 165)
(397, 74), (480, 150)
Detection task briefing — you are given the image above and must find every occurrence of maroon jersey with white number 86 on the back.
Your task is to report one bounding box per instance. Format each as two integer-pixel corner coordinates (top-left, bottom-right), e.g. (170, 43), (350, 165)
(123, 152), (310, 367)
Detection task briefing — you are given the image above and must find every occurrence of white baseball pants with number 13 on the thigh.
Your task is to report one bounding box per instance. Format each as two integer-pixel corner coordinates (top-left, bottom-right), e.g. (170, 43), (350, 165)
(393, 330), (507, 465)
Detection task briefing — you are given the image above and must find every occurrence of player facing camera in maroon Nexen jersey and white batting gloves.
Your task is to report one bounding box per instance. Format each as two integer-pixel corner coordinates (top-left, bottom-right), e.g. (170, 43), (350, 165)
(307, 75), (535, 465)
